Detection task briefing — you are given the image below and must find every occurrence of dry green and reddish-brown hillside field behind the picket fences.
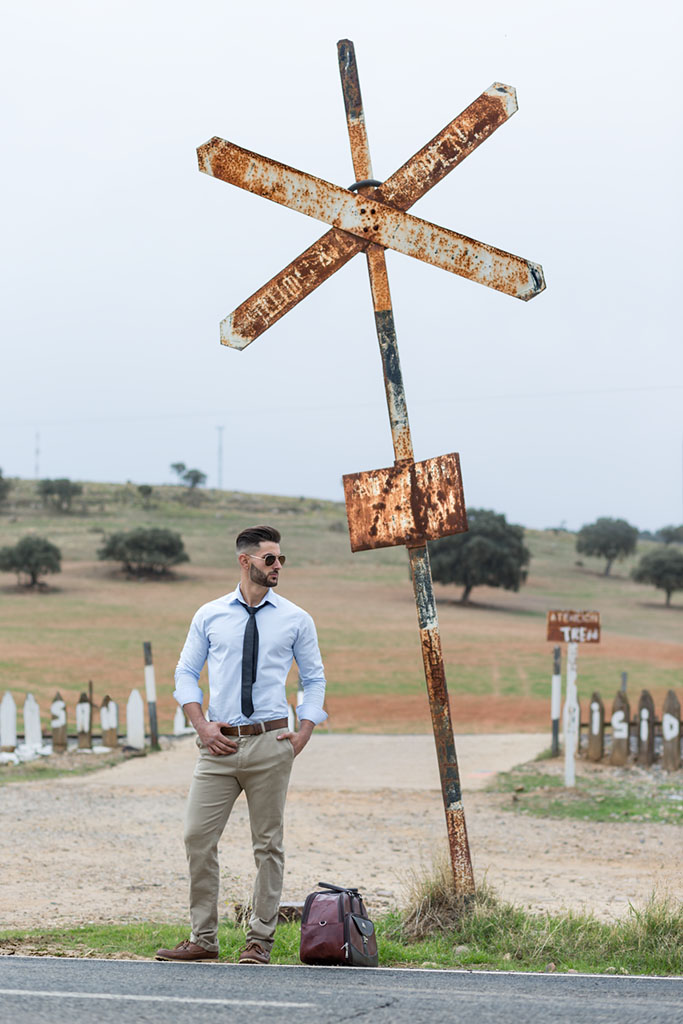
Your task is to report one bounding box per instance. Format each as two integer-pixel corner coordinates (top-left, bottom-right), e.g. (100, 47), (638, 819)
(0, 481), (683, 733)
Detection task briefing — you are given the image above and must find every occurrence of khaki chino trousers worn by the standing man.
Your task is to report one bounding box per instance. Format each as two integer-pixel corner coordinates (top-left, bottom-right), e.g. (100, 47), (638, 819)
(184, 730), (294, 951)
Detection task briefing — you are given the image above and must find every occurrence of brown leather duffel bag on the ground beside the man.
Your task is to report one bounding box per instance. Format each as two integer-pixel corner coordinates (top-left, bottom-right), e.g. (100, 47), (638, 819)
(299, 882), (378, 967)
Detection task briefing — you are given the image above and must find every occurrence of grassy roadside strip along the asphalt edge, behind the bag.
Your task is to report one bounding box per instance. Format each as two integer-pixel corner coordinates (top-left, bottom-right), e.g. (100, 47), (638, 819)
(0, 888), (683, 975)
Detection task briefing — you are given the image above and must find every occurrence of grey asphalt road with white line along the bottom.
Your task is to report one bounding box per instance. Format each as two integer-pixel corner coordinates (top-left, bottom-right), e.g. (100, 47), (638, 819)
(0, 956), (683, 1024)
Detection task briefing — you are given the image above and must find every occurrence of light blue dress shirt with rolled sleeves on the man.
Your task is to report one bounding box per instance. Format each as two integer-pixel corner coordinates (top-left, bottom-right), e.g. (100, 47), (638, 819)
(173, 587), (328, 725)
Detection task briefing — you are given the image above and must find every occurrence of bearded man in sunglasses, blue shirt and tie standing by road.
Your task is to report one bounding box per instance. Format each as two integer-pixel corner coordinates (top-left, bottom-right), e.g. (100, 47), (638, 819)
(157, 526), (328, 964)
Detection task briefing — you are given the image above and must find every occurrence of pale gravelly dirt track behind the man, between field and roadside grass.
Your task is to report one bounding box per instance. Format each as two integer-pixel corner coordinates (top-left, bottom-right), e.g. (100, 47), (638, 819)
(0, 732), (683, 928)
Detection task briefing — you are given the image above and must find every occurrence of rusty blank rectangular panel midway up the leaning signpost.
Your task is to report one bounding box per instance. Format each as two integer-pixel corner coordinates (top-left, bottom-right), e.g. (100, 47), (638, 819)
(343, 452), (467, 551)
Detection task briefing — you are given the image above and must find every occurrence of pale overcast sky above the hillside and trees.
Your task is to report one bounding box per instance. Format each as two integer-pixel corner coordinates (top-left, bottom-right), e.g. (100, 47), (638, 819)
(0, 0), (683, 529)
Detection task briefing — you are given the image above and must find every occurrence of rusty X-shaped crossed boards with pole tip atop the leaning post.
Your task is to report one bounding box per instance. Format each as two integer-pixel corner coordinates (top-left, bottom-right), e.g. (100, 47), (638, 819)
(197, 49), (546, 348)
